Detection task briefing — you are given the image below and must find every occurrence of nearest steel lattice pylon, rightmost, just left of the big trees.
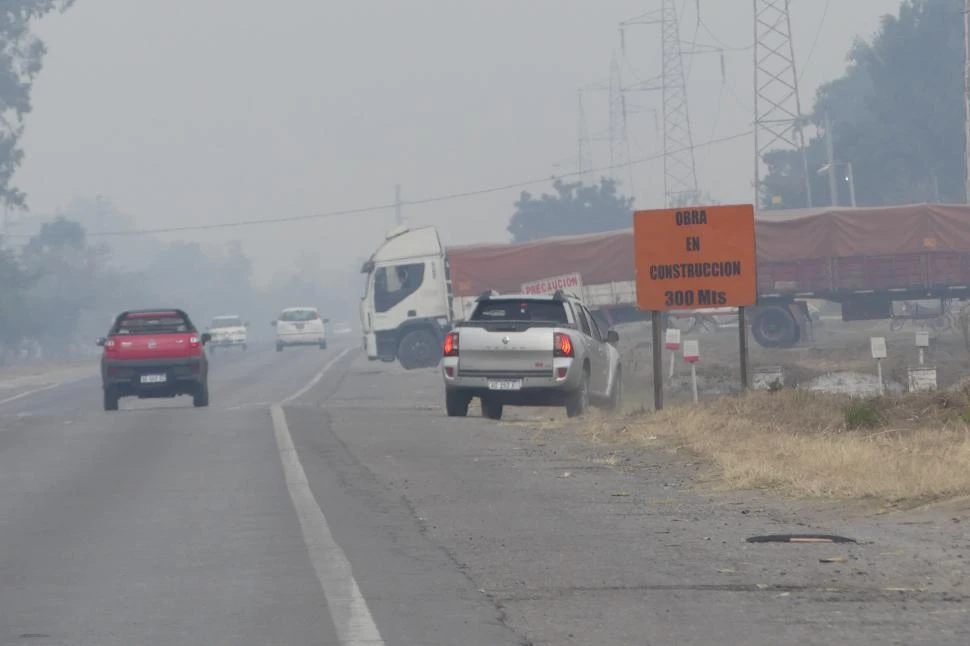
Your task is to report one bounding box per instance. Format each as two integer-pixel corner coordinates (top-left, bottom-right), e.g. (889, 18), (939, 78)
(753, 0), (812, 208)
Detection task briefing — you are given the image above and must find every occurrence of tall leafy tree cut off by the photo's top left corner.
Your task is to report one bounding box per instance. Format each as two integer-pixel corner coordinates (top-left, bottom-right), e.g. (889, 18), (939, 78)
(0, 0), (74, 207)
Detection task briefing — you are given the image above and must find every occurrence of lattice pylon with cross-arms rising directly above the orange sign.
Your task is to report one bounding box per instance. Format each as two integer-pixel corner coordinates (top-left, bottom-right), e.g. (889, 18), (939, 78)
(620, 0), (704, 206)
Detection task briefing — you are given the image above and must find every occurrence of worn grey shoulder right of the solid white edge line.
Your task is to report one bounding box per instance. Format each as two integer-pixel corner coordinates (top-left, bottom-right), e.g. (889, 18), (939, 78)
(287, 360), (970, 646)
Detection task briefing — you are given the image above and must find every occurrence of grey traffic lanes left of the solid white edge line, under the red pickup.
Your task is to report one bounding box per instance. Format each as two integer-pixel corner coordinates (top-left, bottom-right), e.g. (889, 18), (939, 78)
(0, 351), (348, 646)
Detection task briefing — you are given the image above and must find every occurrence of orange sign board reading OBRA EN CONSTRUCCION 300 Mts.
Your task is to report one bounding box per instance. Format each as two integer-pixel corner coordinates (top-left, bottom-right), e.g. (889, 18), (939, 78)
(633, 204), (758, 312)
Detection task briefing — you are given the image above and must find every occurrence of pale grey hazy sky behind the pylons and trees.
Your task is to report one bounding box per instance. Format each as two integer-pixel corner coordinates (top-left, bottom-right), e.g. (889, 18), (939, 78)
(16, 0), (899, 284)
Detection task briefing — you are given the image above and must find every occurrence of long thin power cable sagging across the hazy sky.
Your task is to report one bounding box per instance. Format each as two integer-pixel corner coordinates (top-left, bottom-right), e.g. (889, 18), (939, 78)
(17, 130), (752, 238)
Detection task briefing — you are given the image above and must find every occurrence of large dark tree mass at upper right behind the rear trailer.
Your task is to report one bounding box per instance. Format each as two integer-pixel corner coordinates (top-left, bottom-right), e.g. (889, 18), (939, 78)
(762, 0), (966, 208)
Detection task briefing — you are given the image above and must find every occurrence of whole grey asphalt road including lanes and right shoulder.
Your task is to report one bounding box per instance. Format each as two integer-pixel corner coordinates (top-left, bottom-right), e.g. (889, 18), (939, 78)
(0, 347), (970, 646)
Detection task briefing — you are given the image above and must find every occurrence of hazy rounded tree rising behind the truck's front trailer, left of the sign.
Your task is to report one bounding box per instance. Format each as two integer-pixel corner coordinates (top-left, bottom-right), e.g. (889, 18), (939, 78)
(506, 178), (633, 242)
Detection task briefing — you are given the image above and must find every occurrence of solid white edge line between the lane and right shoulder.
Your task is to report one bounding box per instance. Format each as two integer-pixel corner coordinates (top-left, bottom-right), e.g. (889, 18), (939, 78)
(270, 348), (384, 646)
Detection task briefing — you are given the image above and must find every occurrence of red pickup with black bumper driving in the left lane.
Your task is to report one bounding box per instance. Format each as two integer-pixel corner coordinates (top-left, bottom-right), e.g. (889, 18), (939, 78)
(98, 309), (210, 410)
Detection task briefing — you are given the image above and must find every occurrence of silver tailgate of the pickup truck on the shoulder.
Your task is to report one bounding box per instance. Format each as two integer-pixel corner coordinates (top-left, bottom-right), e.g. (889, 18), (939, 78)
(458, 322), (554, 376)
